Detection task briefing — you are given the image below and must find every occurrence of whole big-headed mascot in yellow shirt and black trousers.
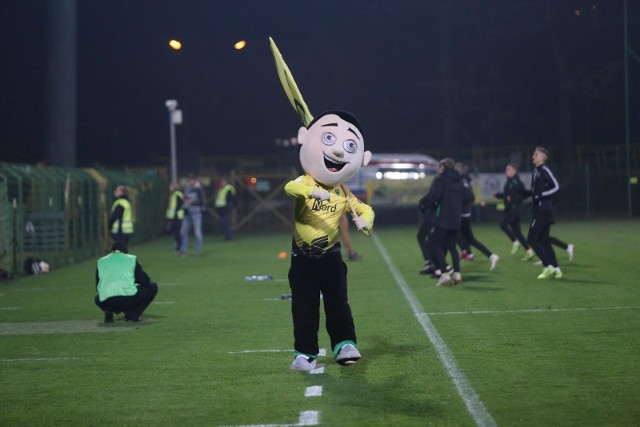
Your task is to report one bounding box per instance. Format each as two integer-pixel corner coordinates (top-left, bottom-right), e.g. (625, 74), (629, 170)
(269, 38), (374, 371)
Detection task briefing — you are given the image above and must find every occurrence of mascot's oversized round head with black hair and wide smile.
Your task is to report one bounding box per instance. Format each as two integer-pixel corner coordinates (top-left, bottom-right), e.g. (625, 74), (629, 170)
(298, 112), (371, 188)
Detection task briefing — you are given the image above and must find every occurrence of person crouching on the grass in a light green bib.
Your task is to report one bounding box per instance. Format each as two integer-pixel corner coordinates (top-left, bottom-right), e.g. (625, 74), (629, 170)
(95, 241), (158, 323)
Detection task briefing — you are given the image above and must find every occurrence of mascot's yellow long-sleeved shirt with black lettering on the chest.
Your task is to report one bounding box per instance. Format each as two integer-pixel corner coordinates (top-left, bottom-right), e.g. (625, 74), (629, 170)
(284, 175), (375, 258)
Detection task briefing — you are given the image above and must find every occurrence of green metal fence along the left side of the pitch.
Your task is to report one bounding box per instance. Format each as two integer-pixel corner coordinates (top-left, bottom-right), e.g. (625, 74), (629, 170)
(0, 163), (168, 276)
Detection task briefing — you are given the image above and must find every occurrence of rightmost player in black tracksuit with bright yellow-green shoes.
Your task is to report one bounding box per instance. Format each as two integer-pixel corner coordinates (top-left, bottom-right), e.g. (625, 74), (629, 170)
(527, 147), (562, 279)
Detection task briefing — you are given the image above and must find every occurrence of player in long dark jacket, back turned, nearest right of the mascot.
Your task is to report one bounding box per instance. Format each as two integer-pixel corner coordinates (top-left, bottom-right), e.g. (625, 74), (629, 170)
(424, 158), (464, 286)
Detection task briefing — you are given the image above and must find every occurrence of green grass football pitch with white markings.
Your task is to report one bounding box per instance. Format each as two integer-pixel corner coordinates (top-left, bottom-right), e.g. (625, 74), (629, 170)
(0, 221), (640, 426)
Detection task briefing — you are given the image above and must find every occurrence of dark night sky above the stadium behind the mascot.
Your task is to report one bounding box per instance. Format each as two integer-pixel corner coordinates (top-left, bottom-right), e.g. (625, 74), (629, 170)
(0, 0), (640, 165)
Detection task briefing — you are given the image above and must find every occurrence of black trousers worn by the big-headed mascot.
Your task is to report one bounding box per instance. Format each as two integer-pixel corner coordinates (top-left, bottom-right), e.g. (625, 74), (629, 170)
(289, 252), (357, 356)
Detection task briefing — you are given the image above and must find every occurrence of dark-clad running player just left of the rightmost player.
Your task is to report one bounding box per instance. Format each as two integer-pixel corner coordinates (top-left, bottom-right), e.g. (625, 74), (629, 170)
(494, 163), (534, 261)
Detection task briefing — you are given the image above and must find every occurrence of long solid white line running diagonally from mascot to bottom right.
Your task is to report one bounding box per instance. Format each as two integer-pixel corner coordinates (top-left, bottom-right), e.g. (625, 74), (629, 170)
(371, 234), (496, 427)
